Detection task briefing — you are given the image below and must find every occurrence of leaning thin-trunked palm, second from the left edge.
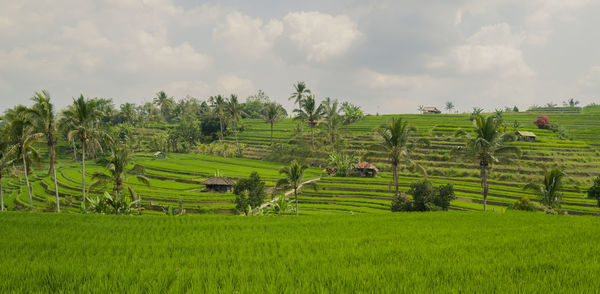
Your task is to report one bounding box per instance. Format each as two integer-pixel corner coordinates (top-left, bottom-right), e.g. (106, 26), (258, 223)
(5, 105), (43, 210)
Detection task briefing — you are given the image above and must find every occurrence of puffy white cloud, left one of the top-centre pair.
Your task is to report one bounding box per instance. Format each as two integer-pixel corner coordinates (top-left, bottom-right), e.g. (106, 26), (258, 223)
(213, 11), (283, 58)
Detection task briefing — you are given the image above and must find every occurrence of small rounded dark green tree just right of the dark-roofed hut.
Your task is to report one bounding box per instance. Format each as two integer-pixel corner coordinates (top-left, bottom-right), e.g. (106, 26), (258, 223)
(233, 171), (266, 213)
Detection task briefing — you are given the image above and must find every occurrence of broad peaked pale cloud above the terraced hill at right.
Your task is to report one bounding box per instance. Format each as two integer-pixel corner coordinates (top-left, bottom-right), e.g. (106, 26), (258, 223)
(428, 23), (535, 78)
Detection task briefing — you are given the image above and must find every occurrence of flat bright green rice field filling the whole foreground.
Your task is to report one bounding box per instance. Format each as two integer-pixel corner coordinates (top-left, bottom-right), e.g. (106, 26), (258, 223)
(0, 212), (600, 293)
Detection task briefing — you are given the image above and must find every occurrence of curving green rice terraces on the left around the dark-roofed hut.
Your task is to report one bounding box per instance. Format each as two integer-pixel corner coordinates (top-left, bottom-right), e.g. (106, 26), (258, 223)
(3, 153), (320, 214)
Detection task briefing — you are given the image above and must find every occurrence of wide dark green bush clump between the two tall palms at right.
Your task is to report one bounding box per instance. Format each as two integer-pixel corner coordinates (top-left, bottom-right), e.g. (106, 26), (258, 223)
(391, 180), (456, 211)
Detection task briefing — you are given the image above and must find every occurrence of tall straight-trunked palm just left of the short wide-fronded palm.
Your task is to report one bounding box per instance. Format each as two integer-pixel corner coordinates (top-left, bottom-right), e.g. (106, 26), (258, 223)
(63, 95), (103, 206)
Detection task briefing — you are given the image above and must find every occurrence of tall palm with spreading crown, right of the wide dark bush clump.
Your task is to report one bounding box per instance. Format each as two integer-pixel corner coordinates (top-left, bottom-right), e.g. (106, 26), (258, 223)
(453, 115), (521, 211)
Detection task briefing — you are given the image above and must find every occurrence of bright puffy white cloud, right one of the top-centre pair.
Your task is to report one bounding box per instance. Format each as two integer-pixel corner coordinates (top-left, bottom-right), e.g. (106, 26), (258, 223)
(283, 12), (361, 62)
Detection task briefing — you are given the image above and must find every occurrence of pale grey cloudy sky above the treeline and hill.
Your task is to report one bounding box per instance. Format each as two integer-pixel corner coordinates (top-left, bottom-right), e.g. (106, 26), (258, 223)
(0, 0), (600, 114)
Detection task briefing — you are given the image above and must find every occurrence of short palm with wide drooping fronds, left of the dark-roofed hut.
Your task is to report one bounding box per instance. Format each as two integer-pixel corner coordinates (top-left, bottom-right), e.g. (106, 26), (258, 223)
(88, 146), (150, 201)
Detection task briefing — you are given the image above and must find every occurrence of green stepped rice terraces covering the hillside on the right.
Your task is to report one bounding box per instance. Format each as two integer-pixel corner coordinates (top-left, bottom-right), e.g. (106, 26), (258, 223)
(228, 108), (600, 214)
